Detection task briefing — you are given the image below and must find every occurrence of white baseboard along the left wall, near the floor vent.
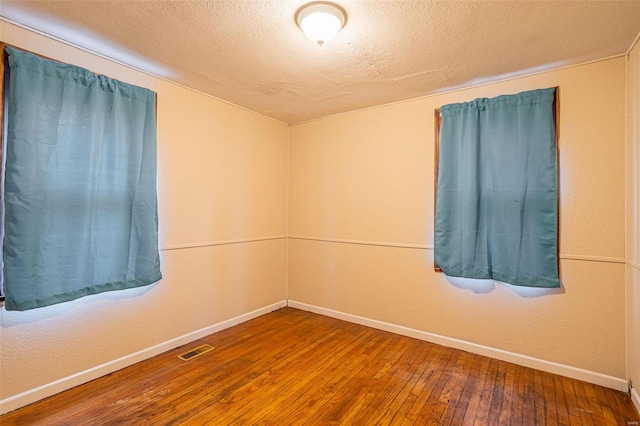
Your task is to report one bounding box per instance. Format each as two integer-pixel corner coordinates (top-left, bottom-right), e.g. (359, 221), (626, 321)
(0, 300), (287, 414)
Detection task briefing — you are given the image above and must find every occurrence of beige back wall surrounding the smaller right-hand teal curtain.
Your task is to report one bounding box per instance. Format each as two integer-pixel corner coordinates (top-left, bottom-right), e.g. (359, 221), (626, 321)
(289, 57), (626, 378)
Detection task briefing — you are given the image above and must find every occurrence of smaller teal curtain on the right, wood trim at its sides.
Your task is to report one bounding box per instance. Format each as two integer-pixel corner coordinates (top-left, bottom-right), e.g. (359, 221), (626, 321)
(435, 89), (560, 288)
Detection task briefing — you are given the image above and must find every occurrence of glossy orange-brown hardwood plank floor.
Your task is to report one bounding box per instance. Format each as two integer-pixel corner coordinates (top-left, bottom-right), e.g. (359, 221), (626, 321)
(0, 308), (639, 426)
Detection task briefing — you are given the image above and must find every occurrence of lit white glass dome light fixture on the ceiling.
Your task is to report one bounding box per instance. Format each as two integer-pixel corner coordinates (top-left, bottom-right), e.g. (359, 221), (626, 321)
(296, 1), (347, 46)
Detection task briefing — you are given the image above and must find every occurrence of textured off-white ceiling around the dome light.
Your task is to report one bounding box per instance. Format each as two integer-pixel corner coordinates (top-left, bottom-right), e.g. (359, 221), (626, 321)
(0, 0), (640, 123)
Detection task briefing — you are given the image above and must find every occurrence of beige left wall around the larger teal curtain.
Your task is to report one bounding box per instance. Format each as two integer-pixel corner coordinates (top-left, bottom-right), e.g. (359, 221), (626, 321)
(0, 22), (288, 400)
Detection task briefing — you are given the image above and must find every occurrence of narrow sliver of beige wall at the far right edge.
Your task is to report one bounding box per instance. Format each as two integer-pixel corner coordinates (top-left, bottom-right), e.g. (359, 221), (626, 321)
(626, 39), (640, 400)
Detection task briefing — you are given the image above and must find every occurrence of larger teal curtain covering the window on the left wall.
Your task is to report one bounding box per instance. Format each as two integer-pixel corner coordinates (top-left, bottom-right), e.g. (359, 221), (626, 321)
(3, 48), (162, 310)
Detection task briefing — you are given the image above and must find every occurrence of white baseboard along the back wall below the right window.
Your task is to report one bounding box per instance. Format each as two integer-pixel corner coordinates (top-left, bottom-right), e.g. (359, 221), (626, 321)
(288, 300), (638, 392)
